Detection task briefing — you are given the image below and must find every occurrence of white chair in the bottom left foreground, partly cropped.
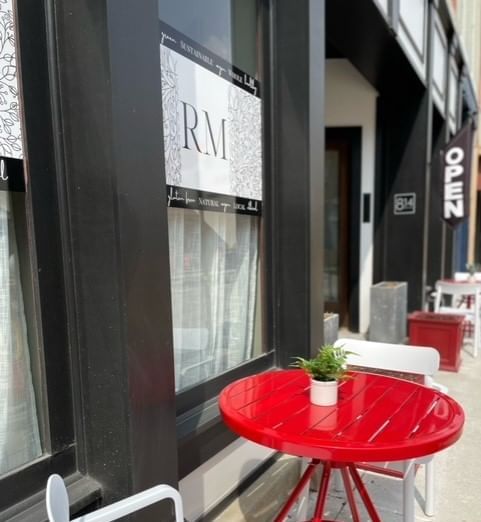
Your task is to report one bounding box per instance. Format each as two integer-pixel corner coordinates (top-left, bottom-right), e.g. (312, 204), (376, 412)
(45, 475), (184, 522)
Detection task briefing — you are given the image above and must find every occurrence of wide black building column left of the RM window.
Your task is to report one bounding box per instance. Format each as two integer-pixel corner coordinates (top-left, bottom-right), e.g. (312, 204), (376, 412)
(48, 0), (177, 520)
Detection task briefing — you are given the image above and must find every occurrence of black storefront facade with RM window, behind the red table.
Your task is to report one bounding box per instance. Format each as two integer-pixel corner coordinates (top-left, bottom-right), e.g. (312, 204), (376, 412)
(0, 0), (476, 522)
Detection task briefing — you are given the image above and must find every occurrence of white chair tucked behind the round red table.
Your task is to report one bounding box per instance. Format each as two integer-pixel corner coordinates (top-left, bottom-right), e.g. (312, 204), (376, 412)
(334, 338), (447, 522)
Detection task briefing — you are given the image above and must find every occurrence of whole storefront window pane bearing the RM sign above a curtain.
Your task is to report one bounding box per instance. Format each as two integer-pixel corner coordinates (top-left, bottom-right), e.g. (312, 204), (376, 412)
(159, 0), (262, 391)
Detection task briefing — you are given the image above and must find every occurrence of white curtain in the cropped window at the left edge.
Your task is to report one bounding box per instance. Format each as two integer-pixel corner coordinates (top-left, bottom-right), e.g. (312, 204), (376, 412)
(0, 191), (42, 475)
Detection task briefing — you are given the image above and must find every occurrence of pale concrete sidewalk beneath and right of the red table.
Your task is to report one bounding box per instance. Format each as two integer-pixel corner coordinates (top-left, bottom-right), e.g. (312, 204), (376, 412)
(291, 344), (481, 522)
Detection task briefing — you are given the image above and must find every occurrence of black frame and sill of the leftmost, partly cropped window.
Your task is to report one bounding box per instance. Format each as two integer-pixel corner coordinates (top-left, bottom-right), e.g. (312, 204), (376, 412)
(0, 0), (83, 520)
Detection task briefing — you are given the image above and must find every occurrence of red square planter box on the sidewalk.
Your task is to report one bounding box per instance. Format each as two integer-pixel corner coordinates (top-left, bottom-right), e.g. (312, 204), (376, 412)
(408, 312), (464, 372)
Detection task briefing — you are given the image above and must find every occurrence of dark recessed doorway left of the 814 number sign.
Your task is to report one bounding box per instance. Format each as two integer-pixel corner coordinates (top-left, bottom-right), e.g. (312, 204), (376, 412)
(324, 127), (360, 331)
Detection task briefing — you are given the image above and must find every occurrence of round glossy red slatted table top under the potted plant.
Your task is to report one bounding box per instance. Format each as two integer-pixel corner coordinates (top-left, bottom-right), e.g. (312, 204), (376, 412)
(219, 370), (464, 462)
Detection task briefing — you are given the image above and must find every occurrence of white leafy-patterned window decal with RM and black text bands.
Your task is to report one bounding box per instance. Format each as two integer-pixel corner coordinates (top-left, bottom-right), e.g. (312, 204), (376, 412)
(160, 22), (262, 215)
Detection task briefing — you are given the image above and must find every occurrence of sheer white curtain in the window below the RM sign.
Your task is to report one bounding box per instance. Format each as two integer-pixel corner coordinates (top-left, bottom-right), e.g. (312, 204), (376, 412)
(169, 208), (259, 389)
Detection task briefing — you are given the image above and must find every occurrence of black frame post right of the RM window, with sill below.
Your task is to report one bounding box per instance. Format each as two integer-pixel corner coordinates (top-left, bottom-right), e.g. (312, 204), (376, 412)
(170, 0), (325, 478)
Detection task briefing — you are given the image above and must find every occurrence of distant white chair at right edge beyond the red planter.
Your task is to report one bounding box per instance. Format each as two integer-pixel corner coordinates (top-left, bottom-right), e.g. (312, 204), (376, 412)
(434, 281), (481, 357)
